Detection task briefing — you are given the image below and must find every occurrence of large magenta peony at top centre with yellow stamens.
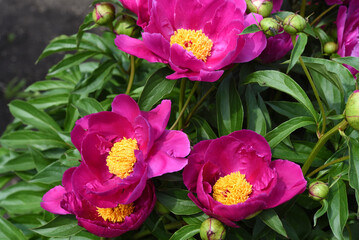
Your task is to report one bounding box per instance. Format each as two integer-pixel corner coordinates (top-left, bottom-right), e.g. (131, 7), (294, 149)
(115, 0), (266, 82)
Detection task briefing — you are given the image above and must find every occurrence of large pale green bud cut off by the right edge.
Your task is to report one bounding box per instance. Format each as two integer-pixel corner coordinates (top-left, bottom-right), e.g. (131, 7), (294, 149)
(345, 90), (359, 131)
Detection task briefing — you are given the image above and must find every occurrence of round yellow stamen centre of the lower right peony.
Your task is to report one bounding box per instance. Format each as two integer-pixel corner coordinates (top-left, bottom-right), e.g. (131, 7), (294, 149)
(213, 171), (252, 205)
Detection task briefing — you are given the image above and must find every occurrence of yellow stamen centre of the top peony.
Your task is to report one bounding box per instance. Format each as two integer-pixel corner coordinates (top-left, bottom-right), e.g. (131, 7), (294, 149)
(170, 28), (213, 62)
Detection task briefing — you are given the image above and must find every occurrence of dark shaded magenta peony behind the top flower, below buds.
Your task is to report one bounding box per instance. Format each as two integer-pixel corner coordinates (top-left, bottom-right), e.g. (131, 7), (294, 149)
(259, 32), (293, 63)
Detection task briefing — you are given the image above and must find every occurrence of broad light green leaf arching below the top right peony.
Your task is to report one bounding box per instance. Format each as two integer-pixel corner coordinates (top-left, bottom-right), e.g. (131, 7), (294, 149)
(302, 57), (355, 101)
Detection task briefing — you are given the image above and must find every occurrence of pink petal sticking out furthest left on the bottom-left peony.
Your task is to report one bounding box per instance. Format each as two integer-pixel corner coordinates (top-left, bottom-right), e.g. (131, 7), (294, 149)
(40, 186), (70, 214)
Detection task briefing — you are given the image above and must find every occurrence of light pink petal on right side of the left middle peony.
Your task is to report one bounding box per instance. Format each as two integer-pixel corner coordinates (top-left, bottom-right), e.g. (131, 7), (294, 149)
(147, 130), (190, 178)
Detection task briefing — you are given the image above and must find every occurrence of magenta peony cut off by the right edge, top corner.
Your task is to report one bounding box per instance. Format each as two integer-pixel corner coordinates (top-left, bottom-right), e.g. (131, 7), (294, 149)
(337, 1), (359, 75)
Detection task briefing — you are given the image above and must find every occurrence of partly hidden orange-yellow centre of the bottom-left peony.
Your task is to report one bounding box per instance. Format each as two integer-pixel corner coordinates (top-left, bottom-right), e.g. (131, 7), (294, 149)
(97, 203), (135, 223)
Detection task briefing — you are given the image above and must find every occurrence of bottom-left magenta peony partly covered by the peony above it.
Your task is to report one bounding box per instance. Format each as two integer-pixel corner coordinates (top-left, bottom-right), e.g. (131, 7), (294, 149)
(41, 168), (156, 238)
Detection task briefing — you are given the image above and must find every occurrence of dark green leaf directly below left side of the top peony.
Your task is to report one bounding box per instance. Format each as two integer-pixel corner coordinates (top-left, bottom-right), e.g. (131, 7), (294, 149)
(138, 67), (176, 111)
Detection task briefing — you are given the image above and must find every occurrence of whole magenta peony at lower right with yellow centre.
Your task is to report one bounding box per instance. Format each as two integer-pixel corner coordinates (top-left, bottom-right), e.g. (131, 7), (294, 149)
(183, 130), (306, 227)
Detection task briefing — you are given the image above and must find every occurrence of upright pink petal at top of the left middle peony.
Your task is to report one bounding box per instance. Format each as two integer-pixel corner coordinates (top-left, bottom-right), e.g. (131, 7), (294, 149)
(112, 94), (140, 122)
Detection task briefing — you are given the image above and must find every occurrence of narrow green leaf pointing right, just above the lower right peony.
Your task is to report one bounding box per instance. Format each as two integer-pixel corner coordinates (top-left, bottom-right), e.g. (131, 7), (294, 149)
(265, 117), (315, 148)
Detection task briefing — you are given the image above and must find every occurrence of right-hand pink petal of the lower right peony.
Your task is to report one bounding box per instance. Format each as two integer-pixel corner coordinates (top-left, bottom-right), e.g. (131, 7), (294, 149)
(266, 160), (307, 208)
